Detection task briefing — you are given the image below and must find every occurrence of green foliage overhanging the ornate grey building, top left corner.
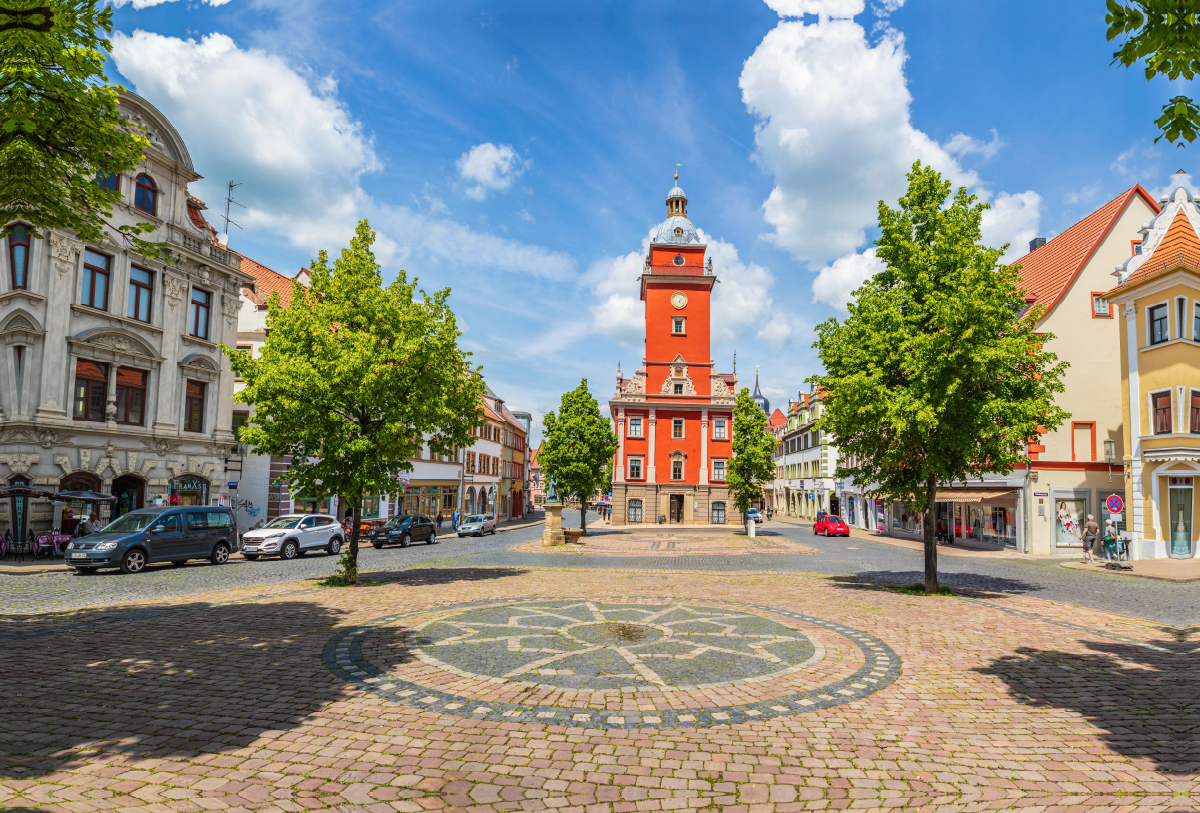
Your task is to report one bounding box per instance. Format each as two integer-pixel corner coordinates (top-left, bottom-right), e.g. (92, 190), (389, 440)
(0, 0), (157, 248)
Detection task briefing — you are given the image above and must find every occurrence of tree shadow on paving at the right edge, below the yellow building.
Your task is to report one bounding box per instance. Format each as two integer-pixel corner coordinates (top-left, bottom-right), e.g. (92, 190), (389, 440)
(978, 627), (1200, 777)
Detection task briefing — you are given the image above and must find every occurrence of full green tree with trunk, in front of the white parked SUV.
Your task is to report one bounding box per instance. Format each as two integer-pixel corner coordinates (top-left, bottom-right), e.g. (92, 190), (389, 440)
(221, 221), (484, 584)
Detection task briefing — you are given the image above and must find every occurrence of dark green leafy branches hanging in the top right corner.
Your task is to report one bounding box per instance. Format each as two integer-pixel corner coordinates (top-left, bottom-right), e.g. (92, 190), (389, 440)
(1104, 0), (1200, 146)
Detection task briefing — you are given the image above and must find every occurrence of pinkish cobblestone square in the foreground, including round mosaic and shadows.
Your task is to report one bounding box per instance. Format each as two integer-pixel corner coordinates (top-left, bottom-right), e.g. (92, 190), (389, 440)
(0, 565), (1200, 813)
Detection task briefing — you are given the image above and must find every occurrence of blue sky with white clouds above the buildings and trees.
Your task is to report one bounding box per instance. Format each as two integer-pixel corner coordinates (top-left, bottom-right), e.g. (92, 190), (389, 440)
(103, 0), (1196, 438)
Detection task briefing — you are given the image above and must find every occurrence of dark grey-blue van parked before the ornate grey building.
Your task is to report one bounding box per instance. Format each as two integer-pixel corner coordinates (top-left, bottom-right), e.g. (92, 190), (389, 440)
(66, 506), (238, 573)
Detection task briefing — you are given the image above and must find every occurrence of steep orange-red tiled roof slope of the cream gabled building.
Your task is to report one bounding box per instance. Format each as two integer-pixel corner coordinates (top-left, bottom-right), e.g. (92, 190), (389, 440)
(1013, 186), (1158, 311)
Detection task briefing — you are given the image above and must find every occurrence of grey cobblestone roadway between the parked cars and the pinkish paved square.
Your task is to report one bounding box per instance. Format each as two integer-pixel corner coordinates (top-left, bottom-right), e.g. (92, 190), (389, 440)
(7, 512), (1200, 623)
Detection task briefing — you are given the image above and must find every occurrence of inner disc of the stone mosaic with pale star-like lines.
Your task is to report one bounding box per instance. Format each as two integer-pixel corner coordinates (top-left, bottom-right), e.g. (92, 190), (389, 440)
(404, 600), (824, 691)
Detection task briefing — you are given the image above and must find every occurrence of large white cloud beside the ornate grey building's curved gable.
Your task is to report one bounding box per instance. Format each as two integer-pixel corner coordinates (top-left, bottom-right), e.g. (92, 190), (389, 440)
(113, 31), (376, 257)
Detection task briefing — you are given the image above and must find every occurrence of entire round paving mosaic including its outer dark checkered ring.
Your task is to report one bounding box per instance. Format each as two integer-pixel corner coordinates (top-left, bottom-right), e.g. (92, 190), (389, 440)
(323, 598), (900, 729)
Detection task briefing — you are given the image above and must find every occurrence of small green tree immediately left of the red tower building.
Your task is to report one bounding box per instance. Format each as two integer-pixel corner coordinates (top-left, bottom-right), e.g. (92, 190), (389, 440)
(538, 379), (617, 534)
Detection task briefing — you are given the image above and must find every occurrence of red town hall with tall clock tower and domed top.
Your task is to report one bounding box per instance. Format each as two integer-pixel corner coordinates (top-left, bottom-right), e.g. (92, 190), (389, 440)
(608, 175), (738, 525)
